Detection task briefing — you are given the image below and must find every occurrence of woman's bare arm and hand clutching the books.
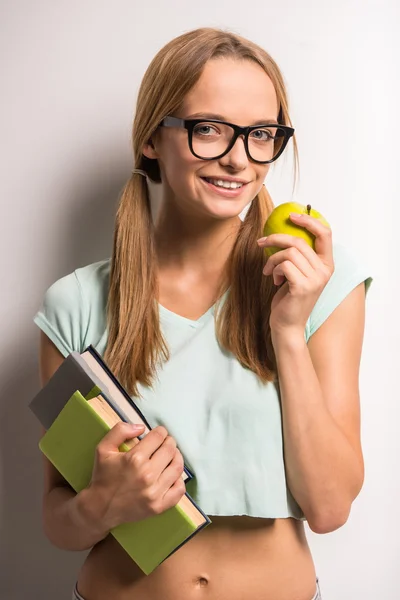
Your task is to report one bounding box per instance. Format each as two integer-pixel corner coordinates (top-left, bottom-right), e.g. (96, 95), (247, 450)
(39, 331), (186, 550)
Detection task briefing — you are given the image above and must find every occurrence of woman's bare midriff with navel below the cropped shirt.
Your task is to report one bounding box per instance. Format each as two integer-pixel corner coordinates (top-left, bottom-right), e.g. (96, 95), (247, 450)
(78, 515), (316, 600)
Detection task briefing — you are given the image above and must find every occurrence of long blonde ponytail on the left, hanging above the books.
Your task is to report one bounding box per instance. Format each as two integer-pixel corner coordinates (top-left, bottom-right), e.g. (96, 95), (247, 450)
(104, 173), (169, 396)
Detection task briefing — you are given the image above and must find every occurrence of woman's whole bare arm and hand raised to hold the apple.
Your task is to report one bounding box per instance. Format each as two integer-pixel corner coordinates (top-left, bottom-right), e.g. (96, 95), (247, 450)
(258, 214), (365, 533)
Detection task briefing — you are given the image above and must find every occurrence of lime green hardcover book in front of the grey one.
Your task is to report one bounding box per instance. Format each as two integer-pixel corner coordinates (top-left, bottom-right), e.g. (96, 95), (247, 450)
(39, 389), (211, 575)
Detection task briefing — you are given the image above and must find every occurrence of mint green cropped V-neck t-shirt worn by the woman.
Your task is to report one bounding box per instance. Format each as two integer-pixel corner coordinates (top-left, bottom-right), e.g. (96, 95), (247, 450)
(34, 243), (372, 520)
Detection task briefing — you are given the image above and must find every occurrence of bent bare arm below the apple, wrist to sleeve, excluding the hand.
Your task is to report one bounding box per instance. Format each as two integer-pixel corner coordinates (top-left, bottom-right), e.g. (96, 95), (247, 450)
(272, 283), (365, 533)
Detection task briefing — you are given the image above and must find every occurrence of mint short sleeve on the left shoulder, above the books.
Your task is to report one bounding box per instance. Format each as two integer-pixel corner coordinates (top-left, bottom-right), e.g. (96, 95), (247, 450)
(33, 271), (86, 357)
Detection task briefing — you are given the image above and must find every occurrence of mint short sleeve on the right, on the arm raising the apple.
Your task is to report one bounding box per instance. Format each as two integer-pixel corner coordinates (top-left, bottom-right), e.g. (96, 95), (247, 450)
(304, 243), (373, 342)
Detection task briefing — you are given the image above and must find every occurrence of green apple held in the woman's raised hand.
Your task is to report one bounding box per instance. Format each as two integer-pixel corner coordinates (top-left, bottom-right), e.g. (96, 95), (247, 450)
(264, 202), (330, 257)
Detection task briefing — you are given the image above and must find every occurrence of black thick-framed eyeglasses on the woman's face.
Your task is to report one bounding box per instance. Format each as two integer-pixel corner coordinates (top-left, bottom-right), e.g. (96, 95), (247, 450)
(160, 115), (295, 164)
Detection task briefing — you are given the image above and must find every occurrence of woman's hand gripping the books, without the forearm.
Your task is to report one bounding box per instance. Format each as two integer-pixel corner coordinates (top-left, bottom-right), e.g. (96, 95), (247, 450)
(85, 422), (186, 530)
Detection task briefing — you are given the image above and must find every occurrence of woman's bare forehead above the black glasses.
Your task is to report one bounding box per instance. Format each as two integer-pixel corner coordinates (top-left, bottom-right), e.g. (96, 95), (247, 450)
(182, 58), (278, 125)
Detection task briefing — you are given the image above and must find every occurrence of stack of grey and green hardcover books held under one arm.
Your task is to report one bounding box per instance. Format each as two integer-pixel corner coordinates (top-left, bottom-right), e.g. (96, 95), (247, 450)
(29, 346), (211, 575)
